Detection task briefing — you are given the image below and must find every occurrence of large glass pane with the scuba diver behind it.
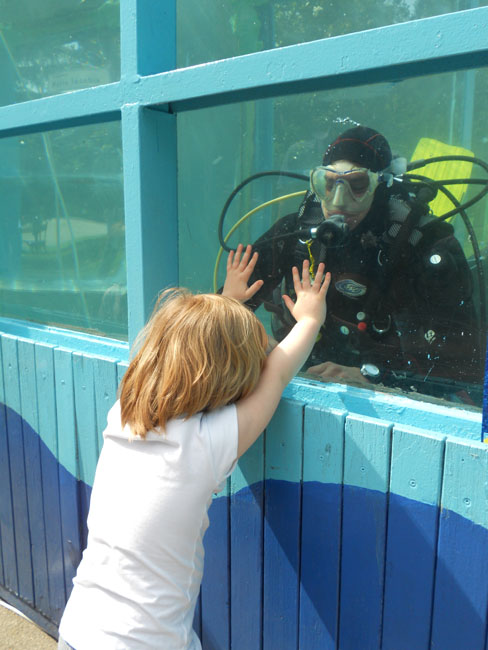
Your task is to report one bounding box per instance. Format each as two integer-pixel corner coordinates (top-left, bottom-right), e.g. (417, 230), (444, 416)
(178, 69), (488, 406)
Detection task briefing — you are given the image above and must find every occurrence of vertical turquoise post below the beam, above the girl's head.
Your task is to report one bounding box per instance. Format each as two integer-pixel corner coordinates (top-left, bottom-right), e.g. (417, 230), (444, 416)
(122, 104), (178, 344)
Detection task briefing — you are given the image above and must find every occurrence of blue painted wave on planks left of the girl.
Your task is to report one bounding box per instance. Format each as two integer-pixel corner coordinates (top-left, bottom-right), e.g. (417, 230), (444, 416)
(0, 405), (91, 623)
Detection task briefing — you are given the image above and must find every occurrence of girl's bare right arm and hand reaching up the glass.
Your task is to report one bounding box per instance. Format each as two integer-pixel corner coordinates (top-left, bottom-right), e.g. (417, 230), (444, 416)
(236, 260), (330, 456)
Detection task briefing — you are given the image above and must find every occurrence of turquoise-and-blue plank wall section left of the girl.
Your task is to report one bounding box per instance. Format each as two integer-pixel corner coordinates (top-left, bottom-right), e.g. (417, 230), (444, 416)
(0, 335), (124, 632)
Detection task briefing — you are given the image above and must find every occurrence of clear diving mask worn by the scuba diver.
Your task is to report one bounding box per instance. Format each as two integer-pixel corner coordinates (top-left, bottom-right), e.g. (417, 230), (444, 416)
(310, 167), (383, 213)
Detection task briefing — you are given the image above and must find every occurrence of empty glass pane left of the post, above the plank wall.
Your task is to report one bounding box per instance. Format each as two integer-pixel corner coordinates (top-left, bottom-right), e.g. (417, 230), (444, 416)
(0, 122), (127, 340)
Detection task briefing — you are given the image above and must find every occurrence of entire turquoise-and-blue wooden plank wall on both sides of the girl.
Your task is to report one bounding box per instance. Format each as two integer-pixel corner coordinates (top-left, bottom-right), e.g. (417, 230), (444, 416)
(0, 335), (488, 650)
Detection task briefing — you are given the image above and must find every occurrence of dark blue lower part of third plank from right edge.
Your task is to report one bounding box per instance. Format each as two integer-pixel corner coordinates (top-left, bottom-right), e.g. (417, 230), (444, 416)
(339, 485), (387, 650)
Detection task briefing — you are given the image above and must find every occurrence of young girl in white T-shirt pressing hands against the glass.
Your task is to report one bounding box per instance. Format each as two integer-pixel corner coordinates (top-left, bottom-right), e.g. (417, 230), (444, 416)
(58, 246), (330, 650)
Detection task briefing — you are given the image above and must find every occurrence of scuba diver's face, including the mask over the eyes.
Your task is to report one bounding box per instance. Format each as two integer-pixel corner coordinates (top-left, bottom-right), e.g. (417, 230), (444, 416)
(321, 160), (374, 230)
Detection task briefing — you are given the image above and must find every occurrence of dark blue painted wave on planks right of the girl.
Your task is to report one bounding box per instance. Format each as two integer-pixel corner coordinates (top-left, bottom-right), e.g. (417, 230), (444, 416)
(214, 480), (488, 650)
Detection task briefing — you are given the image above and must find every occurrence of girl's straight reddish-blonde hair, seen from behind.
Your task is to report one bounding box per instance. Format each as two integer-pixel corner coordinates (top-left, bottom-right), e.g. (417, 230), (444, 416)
(120, 289), (268, 438)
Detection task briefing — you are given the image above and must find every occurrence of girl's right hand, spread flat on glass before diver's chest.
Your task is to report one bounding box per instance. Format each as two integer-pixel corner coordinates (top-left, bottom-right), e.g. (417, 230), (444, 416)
(283, 260), (330, 326)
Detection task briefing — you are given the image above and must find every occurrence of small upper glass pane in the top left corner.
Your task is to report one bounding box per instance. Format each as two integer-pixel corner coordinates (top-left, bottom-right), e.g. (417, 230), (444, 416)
(0, 0), (120, 105)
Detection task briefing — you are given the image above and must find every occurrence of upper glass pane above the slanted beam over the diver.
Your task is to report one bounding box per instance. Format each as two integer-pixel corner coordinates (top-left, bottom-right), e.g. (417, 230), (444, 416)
(177, 0), (488, 67)
